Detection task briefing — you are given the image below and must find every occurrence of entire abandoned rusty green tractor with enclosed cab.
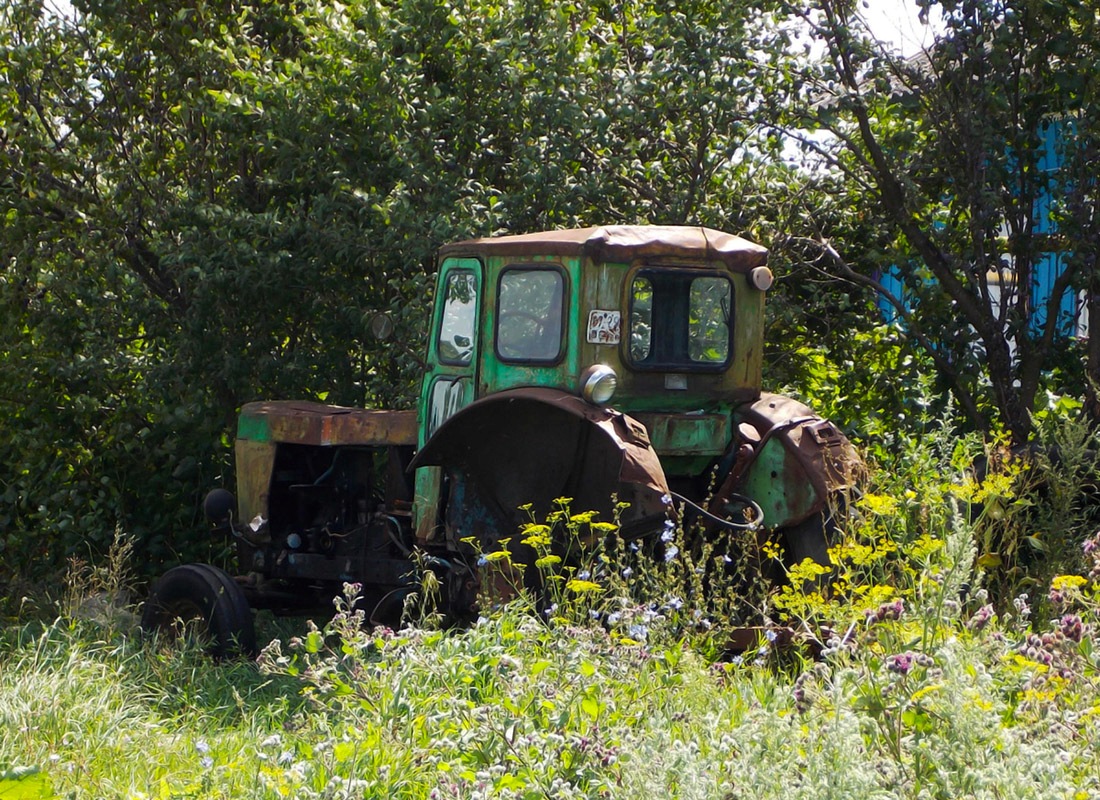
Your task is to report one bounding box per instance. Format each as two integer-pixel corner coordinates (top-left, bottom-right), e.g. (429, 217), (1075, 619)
(143, 226), (859, 653)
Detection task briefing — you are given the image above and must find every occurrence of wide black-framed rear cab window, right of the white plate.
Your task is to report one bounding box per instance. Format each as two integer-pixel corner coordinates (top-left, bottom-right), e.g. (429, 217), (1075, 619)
(630, 270), (733, 371)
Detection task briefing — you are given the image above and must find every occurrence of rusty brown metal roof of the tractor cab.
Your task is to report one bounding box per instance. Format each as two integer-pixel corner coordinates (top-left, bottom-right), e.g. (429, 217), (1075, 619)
(439, 226), (768, 273)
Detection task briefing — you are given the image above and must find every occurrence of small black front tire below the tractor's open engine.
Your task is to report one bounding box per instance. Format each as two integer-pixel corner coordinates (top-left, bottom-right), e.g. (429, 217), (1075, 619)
(141, 563), (257, 658)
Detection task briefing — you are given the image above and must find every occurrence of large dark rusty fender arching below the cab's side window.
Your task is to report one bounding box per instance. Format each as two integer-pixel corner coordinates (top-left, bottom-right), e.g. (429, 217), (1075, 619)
(411, 387), (669, 529)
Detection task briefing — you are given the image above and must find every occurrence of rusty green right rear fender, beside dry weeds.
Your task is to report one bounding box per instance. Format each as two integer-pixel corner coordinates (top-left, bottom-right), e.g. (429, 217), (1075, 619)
(735, 394), (864, 529)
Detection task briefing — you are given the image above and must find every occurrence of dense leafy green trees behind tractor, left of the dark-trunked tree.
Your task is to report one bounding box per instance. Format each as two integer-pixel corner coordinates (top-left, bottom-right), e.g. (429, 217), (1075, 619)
(0, 0), (818, 576)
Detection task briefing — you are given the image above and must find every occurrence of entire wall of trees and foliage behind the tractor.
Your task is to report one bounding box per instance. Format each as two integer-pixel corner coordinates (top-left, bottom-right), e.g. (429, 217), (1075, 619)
(0, 0), (1100, 583)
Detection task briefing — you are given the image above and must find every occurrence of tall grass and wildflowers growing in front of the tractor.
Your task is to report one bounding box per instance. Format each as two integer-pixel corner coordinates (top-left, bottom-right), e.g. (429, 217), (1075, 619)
(0, 415), (1100, 800)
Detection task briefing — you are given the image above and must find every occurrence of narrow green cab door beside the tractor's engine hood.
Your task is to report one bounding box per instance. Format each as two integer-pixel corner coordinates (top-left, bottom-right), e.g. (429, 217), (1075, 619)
(413, 257), (483, 541)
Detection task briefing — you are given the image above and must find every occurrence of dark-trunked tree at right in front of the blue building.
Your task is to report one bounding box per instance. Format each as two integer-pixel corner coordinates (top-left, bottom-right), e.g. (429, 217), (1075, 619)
(772, 0), (1100, 443)
